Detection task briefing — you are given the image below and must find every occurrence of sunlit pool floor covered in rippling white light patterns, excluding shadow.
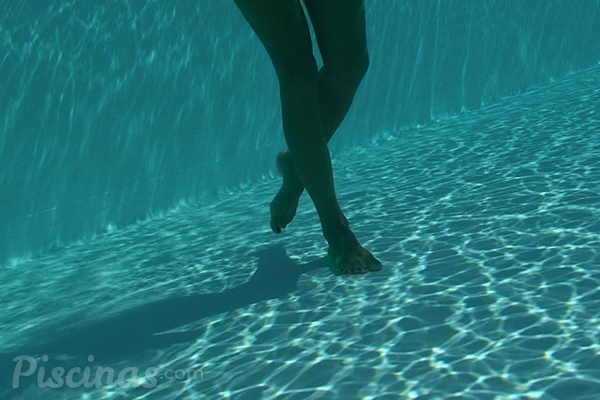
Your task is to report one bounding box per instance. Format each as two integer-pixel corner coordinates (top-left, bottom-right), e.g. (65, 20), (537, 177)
(0, 68), (600, 400)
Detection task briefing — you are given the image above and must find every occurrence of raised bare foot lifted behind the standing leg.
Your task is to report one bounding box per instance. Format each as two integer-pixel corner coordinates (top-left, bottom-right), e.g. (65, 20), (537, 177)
(270, 150), (304, 233)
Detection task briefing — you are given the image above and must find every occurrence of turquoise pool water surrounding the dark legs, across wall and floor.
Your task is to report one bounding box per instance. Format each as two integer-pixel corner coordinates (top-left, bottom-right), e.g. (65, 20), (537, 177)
(0, 0), (600, 400)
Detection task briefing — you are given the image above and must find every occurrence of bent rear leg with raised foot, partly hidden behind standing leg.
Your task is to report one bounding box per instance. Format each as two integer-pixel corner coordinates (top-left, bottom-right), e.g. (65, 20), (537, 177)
(271, 0), (369, 233)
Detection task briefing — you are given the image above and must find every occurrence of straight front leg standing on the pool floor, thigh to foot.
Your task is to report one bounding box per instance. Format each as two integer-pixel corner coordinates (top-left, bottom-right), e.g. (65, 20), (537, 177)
(235, 0), (381, 273)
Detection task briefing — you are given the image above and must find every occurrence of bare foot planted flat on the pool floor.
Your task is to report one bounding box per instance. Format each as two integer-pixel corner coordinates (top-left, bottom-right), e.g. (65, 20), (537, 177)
(326, 225), (383, 275)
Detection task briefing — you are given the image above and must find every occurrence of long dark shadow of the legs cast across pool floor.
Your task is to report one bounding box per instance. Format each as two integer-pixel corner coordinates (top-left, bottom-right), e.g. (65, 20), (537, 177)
(0, 245), (325, 396)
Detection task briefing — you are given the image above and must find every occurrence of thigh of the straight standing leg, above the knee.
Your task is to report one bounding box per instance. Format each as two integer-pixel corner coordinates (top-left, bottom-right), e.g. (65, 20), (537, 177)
(234, 0), (316, 78)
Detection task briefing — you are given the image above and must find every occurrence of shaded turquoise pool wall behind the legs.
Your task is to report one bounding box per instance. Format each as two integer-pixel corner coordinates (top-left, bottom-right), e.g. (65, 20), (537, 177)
(0, 0), (600, 264)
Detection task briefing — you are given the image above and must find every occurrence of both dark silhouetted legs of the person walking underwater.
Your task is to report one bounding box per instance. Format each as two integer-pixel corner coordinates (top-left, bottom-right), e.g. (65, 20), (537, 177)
(235, 0), (381, 274)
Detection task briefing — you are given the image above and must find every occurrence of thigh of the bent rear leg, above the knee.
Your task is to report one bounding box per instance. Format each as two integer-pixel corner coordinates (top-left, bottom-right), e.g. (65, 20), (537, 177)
(303, 0), (369, 72)
